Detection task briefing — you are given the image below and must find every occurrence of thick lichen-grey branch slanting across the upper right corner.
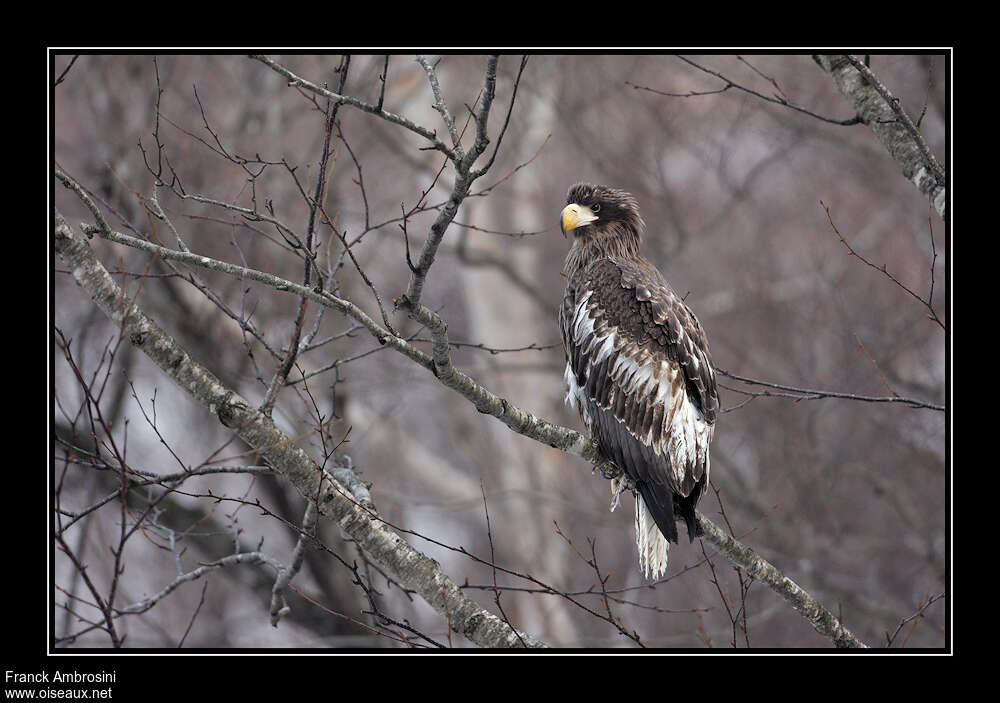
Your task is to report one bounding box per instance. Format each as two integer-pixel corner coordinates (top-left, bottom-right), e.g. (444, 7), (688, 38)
(813, 54), (948, 218)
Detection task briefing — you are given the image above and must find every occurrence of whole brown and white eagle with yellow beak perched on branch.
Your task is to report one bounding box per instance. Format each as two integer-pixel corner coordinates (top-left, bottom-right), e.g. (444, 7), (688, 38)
(559, 183), (719, 579)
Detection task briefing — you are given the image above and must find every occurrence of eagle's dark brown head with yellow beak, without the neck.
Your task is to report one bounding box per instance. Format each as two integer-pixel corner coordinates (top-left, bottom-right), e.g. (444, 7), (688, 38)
(559, 183), (643, 241)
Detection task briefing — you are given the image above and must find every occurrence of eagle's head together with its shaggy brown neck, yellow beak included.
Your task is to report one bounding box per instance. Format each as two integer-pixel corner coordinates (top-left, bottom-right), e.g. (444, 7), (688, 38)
(559, 183), (644, 272)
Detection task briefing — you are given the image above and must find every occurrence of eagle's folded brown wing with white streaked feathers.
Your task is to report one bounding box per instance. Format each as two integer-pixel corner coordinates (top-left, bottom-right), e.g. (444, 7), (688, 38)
(559, 258), (719, 542)
